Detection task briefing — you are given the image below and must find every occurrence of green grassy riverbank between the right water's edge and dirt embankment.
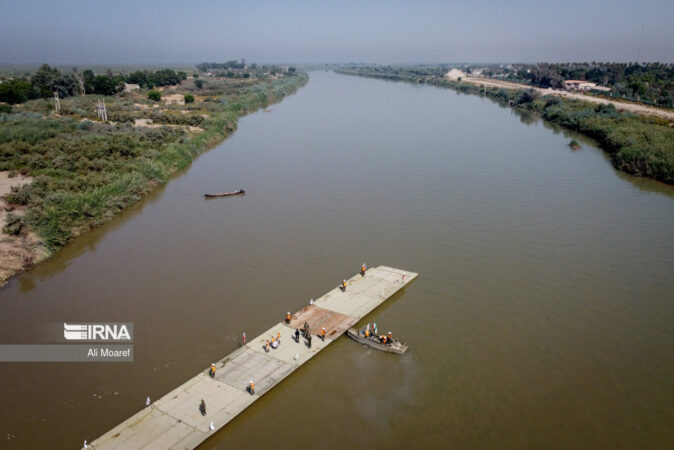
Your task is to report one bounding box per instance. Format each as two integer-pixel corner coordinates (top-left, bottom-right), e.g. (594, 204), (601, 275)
(336, 66), (674, 184)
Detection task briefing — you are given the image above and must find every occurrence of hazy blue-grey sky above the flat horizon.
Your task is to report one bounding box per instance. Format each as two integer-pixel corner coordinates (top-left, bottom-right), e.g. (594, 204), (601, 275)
(0, 0), (674, 64)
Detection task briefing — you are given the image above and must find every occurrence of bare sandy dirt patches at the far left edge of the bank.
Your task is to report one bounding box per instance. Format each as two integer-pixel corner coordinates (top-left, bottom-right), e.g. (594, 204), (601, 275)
(0, 172), (47, 286)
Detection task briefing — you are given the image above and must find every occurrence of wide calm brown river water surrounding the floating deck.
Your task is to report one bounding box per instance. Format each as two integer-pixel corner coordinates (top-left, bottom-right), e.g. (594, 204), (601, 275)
(0, 72), (674, 449)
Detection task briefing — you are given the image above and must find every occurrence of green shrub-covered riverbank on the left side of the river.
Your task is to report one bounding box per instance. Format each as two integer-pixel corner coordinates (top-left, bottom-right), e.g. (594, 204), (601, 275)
(0, 73), (308, 284)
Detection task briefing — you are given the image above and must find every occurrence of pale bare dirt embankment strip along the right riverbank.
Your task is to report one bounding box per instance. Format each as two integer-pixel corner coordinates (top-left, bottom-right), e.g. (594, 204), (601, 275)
(461, 77), (674, 121)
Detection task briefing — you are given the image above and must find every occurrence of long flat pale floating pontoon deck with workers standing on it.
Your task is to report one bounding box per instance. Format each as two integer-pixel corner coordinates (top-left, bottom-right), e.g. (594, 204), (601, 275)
(89, 266), (417, 449)
